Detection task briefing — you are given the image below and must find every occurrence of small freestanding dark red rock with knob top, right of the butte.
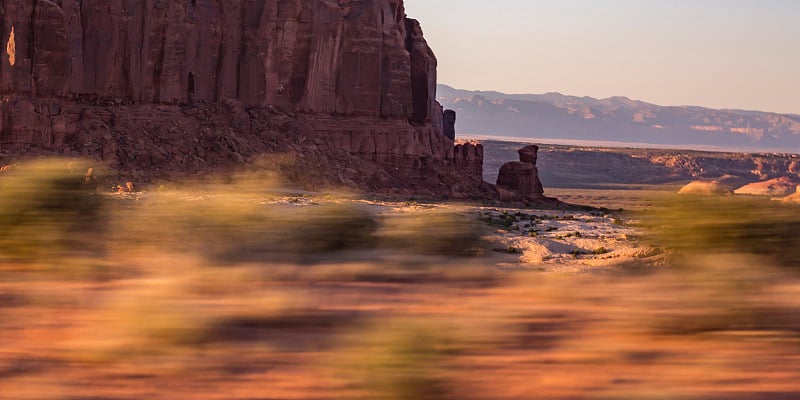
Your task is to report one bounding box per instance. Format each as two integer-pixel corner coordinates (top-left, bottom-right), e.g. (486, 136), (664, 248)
(497, 145), (544, 200)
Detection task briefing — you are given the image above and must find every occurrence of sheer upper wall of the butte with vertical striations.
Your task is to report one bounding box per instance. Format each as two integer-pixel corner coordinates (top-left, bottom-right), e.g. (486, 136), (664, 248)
(0, 0), (424, 111)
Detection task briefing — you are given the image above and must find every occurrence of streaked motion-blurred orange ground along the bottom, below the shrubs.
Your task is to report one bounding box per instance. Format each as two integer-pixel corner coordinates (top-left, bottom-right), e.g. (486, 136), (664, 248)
(0, 255), (800, 399)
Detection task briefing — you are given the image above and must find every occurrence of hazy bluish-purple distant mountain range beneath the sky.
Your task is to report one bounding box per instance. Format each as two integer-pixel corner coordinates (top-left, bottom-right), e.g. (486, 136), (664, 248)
(437, 85), (800, 153)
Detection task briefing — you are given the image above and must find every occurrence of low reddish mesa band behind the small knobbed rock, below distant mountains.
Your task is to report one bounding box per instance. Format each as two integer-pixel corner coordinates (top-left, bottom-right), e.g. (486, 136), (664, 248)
(482, 141), (800, 191)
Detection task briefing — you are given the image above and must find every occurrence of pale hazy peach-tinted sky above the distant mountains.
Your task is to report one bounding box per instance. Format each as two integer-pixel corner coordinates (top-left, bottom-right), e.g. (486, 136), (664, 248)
(405, 0), (800, 114)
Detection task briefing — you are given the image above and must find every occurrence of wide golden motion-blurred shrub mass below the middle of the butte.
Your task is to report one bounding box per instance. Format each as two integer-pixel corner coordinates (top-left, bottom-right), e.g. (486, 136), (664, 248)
(122, 192), (376, 263)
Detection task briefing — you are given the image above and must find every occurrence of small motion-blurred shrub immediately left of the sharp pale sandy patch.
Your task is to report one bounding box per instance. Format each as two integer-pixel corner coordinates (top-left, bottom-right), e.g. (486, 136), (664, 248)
(379, 210), (483, 256)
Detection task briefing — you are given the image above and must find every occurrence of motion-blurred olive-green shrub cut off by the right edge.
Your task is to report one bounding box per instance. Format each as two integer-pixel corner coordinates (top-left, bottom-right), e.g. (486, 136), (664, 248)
(649, 196), (800, 268)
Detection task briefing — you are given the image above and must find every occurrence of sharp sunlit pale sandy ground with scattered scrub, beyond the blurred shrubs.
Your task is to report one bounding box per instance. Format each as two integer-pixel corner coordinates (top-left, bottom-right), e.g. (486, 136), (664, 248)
(344, 196), (661, 274)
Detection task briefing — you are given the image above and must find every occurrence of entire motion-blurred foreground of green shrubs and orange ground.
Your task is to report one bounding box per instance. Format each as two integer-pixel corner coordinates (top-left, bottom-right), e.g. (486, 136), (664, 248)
(0, 160), (800, 399)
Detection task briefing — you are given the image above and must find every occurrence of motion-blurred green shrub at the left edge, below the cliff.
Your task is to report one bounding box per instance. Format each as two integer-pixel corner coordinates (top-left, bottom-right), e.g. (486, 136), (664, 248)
(0, 160), (106, 262)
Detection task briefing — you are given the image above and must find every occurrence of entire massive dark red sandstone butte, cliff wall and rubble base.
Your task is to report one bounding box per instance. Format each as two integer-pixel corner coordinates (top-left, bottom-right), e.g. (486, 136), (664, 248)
(0, 0), (544, 198)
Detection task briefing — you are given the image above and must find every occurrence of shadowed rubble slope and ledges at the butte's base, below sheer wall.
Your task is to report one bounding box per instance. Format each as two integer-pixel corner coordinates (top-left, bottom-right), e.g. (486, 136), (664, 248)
(0, 96), (493, 198)
